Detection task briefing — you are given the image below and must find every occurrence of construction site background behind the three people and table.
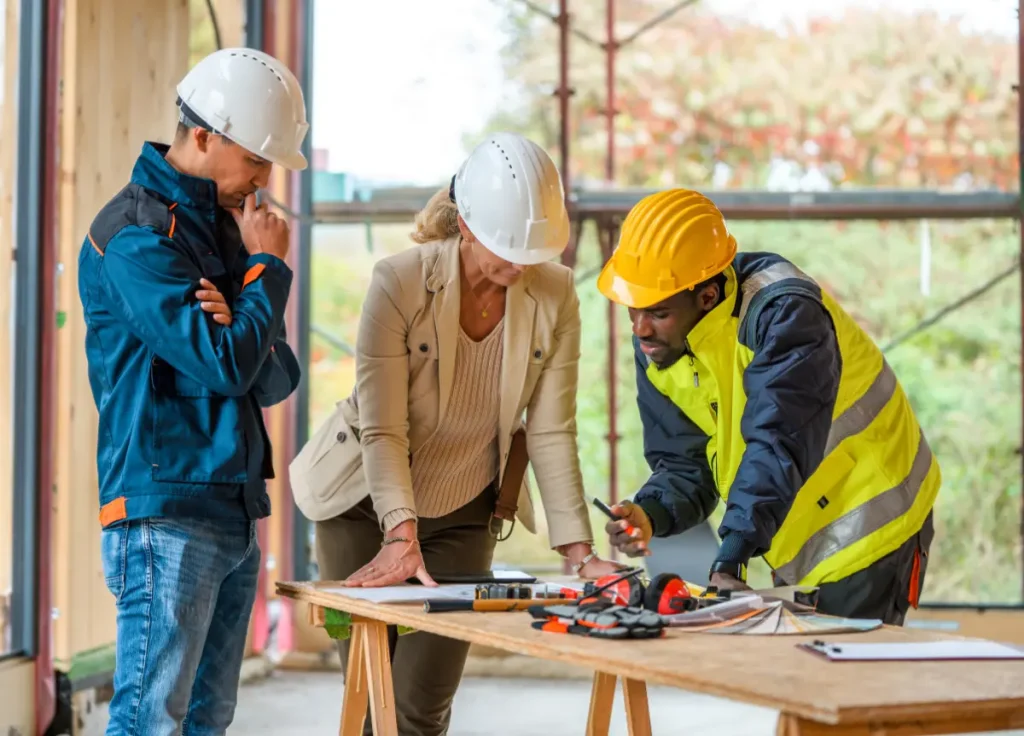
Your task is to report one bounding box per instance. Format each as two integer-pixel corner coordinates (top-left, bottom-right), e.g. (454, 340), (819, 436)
(0, 0), (1024, 736)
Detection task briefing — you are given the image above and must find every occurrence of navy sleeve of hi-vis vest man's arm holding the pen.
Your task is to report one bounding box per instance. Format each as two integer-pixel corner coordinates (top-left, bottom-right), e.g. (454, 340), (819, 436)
(633, 339), (718, 536)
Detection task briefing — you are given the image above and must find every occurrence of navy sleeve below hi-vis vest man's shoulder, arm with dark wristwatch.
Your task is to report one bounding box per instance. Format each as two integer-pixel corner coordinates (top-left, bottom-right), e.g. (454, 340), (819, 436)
(718, 295), (841, 563)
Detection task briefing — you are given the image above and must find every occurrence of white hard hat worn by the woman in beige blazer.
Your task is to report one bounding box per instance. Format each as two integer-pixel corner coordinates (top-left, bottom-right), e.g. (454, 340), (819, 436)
(452, 133), (569, 265)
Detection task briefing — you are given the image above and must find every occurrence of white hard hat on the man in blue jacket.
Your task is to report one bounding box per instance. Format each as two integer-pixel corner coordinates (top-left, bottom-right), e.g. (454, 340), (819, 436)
(178, 48), (309, 170)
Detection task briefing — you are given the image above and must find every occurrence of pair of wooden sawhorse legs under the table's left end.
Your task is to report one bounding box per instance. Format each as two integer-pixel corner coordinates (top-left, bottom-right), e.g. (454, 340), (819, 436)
(338, 616), (398, 736)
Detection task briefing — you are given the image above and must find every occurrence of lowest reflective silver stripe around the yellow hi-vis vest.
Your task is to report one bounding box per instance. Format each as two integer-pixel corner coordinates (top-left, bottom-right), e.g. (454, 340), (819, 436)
(775, 432), (932, 585)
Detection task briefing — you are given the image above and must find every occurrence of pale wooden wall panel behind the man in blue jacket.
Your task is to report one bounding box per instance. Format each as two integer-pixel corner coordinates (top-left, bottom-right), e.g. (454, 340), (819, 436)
(52, 0), (189, 666)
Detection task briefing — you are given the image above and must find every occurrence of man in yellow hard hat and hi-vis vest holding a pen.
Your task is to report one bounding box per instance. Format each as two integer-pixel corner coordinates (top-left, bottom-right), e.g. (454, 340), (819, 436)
(598, 189), (940, 624)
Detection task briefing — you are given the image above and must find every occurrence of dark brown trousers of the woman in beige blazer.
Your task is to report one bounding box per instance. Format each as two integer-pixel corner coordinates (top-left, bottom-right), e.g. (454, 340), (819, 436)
(316, 487), (496, 736)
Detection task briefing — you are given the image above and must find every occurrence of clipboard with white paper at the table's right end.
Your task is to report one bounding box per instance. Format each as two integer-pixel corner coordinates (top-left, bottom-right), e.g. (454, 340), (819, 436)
(797, 639), (1024, 662)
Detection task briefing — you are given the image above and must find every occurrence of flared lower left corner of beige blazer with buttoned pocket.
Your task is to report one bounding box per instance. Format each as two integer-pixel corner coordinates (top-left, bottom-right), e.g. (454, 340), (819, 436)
(289, 402), (362, 521)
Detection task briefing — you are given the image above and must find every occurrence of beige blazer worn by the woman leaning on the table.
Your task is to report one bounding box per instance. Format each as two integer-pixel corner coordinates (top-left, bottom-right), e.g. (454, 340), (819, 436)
(292, 236), (593, 547)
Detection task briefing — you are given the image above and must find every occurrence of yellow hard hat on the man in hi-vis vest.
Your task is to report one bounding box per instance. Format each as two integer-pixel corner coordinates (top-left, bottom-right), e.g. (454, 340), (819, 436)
(597, 189), (736, 309)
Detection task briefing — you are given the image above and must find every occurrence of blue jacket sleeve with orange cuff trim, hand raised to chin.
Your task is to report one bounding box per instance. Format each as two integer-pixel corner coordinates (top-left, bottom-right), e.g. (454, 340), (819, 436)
(99, 225), (292, 396)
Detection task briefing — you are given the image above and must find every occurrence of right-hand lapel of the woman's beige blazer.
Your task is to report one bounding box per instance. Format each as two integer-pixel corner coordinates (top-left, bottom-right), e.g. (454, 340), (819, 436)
(498, 271), (537, 481)
